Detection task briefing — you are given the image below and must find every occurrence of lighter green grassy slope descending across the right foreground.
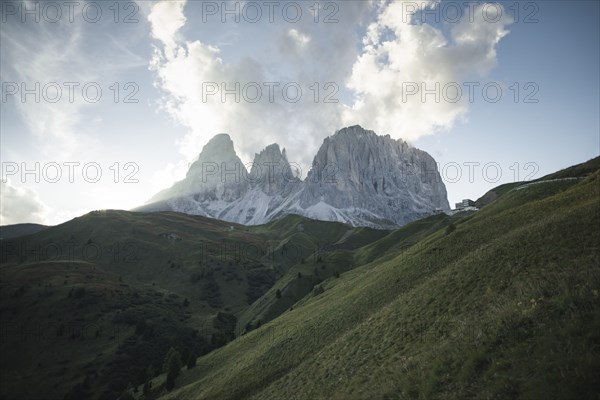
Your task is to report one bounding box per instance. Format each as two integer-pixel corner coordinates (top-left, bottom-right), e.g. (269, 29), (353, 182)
(155, 159), (600, 400)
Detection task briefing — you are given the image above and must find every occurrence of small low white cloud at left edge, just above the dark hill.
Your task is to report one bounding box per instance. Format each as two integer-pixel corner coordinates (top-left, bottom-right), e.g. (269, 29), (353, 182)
(0, 179), (50, 225)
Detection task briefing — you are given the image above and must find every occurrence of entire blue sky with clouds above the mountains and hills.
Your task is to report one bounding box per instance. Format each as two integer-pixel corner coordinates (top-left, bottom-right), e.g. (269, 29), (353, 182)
(0, 0), (600, 225)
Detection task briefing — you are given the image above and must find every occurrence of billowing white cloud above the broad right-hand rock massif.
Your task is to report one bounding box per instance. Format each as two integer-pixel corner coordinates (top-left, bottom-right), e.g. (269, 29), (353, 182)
(343, 1), (512, 140)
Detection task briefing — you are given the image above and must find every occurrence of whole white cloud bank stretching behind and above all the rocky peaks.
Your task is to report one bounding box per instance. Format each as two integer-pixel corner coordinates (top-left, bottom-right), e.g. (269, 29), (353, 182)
(149, 0), (511, 173)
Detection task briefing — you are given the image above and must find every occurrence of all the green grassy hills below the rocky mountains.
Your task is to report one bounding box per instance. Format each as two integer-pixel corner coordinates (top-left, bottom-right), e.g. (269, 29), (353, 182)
(0, 159), (600, 400)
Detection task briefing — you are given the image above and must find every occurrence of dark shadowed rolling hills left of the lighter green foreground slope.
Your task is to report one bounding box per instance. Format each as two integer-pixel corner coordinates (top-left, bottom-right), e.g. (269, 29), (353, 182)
(0, 210), (367, 399)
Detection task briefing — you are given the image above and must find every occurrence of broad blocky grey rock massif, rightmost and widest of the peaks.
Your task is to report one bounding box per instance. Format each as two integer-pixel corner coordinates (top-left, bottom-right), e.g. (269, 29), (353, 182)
(300, 126), (449, 225)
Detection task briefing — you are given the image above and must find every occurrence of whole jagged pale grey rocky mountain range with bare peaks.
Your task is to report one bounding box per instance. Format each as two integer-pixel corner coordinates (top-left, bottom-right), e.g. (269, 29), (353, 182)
(134, 126), (449, 229)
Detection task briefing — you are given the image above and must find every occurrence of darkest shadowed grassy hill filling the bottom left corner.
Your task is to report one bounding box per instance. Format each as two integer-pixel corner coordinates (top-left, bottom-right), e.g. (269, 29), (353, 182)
(0, 261), (198, 399)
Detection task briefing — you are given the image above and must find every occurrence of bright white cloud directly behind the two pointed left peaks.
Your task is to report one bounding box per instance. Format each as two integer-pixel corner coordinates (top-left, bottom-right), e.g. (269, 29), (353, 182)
(149, 3), (350, 170)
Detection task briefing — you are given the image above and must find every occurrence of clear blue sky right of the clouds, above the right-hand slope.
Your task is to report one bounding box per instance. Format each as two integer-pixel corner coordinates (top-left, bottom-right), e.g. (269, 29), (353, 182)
(416, 1), (600, 204)
